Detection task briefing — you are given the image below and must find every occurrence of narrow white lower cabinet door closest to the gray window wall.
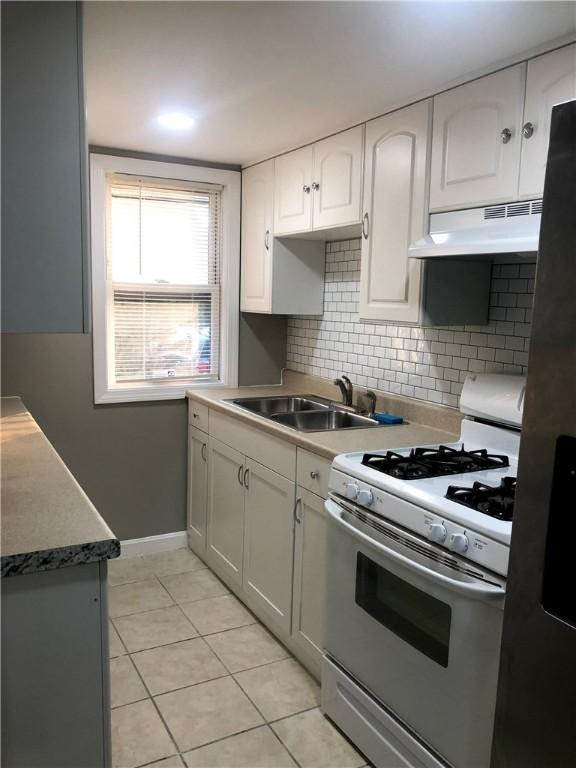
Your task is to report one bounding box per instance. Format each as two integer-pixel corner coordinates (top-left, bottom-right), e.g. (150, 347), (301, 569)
(188, 427), (208, 555)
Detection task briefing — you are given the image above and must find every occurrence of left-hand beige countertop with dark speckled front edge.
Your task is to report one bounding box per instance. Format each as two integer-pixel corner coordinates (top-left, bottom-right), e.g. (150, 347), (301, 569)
(0, 397), (120, 577)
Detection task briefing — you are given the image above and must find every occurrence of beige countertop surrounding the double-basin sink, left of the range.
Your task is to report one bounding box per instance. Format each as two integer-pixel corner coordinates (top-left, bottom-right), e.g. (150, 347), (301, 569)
(187, 377), (458, 460)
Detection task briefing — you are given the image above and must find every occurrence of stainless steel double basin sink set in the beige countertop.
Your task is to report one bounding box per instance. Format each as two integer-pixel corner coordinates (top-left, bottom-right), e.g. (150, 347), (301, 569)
(227, 395), (382, 432)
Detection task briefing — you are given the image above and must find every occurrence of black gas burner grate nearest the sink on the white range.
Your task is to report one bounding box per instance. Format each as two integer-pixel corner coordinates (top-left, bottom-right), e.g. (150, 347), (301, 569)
(362, 445), (509, 480)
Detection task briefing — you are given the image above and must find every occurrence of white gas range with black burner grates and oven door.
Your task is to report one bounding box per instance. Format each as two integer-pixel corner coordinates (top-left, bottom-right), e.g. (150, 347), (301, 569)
(322, 374), (525, 768)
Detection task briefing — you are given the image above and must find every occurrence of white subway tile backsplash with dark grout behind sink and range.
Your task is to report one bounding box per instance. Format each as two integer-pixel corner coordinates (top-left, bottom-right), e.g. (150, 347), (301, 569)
(287, 239), (536, 407)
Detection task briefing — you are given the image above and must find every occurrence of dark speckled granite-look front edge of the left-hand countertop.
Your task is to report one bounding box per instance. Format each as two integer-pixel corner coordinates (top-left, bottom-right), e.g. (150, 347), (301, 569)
(0, 539), (120, 579)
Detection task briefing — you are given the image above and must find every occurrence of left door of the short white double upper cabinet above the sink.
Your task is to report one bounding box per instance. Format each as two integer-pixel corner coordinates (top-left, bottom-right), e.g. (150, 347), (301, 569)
(274, 147), (312, 235)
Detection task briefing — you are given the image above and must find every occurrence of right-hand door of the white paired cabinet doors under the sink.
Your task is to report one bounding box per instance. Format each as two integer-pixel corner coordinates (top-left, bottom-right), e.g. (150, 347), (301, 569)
(244, 459), (295, 633)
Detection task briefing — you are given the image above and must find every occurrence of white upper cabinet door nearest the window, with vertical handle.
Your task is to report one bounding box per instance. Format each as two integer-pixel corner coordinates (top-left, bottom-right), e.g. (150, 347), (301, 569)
(240, 160), (274, 312)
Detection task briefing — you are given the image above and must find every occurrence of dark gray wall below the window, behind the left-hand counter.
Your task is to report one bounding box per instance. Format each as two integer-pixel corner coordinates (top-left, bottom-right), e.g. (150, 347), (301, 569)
(2, 334), (187, 539)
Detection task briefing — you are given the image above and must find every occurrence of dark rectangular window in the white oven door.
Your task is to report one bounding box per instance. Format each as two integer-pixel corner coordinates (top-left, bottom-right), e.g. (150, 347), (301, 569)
(356, 552), (452, 667)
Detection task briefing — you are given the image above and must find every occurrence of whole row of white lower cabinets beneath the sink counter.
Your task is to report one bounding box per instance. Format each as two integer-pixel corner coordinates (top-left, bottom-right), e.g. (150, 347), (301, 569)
(188, 402), (330, 677)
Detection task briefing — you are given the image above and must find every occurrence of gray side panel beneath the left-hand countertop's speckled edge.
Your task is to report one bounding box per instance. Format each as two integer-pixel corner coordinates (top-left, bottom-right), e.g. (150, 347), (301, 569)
(2, 563), (110, 768)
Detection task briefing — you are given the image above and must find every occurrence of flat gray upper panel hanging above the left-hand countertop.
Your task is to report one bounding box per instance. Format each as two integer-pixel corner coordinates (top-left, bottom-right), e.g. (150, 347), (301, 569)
(2, 2), (83, 332)
